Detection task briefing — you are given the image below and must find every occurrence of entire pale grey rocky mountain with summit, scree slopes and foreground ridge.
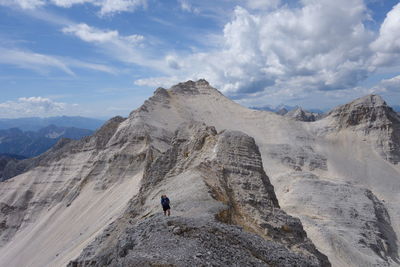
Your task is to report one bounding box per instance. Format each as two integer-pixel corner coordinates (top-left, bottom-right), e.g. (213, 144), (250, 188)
(0, 80), (400, 266)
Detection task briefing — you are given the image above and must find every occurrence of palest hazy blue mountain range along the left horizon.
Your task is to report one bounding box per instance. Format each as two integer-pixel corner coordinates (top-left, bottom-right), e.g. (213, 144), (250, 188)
(0, 116), (104, 131)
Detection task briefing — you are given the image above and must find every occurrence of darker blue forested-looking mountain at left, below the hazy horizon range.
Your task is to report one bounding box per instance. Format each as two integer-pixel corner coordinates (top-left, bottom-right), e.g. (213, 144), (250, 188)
(0, 125), (93, 157)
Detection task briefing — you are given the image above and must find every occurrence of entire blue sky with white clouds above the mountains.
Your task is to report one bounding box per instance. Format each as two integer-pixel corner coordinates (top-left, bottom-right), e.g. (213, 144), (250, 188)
(0, 0), (400, 118)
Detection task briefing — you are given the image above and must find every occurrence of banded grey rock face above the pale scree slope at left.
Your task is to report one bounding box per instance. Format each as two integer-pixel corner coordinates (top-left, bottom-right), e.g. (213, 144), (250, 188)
(0, 117), (129, 251)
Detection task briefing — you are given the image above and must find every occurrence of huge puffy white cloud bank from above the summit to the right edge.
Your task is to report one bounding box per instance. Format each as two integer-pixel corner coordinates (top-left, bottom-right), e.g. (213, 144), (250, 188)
(136, 0), (400, 105)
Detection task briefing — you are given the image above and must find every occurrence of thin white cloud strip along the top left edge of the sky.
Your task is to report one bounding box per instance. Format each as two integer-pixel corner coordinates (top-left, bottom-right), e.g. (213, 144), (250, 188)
(0, 0), (147, 16)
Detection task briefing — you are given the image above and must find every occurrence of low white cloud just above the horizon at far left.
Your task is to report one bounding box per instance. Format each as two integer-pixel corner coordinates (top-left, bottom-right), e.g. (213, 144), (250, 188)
(0, 96), (68, 118)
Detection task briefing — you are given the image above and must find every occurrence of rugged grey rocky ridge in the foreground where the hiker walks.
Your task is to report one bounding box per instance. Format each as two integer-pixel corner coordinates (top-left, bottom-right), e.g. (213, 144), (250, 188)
(69, 124), (330, 266)
